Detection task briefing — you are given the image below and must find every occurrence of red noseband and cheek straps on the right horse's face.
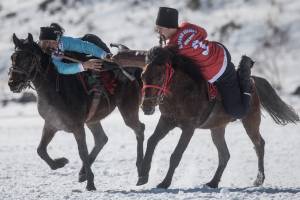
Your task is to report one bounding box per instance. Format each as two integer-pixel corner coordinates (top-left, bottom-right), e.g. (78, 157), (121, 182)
(142, 62), (174, 104)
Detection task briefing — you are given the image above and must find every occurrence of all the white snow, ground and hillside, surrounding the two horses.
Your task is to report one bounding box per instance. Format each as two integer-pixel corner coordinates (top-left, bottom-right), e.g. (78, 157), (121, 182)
(0, 0), (300, 200)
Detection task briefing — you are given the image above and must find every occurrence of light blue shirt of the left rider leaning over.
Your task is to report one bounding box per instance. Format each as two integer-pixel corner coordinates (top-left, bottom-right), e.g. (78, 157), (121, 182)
(52, 36), (107, 74)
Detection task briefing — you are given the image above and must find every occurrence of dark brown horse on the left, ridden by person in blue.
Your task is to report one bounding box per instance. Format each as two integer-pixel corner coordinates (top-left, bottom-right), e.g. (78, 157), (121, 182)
(8, 33), (145, 191)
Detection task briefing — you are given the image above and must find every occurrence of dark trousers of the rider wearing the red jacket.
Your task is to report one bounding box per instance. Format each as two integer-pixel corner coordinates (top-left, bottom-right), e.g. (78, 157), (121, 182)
(215, 45), (251, 119)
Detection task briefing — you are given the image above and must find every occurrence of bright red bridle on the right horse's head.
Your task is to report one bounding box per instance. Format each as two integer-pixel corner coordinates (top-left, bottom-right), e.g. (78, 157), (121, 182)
(142, 62), (174, 101)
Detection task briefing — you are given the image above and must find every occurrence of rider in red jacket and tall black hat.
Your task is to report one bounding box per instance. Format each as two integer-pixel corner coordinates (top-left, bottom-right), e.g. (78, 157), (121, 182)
(156, 7), (254, 118)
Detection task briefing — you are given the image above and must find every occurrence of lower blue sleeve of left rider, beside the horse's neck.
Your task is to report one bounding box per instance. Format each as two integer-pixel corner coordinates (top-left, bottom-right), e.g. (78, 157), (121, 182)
(52, 59), (85, 74)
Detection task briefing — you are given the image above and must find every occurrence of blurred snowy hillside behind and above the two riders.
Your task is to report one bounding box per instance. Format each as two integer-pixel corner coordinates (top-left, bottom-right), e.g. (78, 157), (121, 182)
(0, 0), (300, 92)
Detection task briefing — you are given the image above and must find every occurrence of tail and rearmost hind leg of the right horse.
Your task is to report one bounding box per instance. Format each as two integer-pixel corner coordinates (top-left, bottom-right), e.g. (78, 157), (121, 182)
(242, 76), (299, 186)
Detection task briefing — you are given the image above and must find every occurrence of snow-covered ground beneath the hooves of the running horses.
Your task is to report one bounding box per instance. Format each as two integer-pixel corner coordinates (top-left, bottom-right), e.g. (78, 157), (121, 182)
(0, 98), (300, 200)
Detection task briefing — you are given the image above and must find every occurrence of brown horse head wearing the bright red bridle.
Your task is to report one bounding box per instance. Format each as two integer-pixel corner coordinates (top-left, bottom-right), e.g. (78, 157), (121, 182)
(142, 46), (175, 115)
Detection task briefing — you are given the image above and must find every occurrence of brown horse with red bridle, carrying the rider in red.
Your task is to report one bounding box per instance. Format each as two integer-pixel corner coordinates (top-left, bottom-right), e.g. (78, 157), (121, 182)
(137, 47), (299, 188)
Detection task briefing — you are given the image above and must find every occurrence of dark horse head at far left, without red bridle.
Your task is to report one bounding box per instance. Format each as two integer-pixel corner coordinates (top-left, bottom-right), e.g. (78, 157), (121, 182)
(8, 33), (41, 93)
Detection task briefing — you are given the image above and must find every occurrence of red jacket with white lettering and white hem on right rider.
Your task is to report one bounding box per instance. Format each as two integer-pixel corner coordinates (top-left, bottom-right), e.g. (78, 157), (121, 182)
(167, 22), (227, 83)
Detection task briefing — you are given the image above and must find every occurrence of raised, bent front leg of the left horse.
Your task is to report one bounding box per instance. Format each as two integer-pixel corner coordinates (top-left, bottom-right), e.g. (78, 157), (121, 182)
(37, 123), (69, 170)
